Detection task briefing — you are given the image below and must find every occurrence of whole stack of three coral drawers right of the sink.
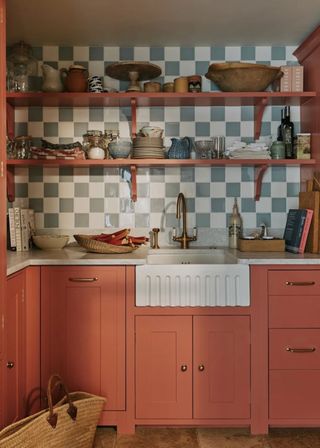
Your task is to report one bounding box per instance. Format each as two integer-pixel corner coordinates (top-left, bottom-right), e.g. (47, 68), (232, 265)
(268, 269), (320, 424)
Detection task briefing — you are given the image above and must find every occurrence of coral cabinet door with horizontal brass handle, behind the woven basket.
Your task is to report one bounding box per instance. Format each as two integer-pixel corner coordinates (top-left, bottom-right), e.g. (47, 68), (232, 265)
(41, 266), (125, 410)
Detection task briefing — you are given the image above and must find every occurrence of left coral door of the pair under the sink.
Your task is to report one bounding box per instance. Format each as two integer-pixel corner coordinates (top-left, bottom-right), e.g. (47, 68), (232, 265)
(136, 316), (192, 419)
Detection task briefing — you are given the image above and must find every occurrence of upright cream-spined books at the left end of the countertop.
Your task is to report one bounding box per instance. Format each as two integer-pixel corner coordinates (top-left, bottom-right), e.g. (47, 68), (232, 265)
(8, 207), (35, 252)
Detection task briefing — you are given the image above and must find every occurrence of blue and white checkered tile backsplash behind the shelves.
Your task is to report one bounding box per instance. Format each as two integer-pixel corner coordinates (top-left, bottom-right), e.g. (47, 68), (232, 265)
(15, 46), (300, 234)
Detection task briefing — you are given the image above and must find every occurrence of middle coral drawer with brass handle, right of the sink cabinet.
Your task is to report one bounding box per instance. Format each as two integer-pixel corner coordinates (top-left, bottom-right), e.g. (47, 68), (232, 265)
(269, 329), (320, 369)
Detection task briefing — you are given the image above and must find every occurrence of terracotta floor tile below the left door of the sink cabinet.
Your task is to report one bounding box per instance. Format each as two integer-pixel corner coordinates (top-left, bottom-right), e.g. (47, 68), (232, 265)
(116, 428), (199, 448)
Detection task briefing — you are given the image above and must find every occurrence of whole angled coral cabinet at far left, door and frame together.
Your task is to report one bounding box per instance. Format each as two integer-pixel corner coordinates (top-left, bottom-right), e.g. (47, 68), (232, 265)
(4, 267), (40, 424)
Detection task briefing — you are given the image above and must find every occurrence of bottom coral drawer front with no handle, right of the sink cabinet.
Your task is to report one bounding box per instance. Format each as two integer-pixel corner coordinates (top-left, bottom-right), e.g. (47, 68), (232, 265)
(269, 370), (320, 420)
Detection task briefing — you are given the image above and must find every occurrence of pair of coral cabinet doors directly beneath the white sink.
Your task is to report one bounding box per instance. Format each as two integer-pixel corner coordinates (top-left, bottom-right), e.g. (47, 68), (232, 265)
(135, 316), (250, 420)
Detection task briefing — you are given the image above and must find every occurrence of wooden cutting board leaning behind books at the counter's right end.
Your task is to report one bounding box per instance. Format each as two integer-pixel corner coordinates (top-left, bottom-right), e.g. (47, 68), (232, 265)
(299, 191), (320, 254)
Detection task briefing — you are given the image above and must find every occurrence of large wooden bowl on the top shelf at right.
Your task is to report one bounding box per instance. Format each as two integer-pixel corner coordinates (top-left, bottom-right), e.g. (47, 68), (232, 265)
(206, 62), (283, 92)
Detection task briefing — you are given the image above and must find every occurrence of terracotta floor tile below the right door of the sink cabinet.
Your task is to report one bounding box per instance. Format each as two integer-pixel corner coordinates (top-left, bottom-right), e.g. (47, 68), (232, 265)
(197, 428), (268, 448)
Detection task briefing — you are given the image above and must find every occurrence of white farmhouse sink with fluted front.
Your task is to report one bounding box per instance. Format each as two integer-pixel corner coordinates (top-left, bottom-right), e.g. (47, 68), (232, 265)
(136, 249), (250, 306)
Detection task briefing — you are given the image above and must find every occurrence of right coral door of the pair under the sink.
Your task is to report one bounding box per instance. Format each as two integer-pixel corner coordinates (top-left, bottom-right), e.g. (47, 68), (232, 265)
(193, 316), (250, 418)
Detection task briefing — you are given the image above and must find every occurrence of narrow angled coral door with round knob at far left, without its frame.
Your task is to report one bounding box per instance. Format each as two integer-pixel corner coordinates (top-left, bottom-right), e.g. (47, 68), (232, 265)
(5, 272), (25, 425)
